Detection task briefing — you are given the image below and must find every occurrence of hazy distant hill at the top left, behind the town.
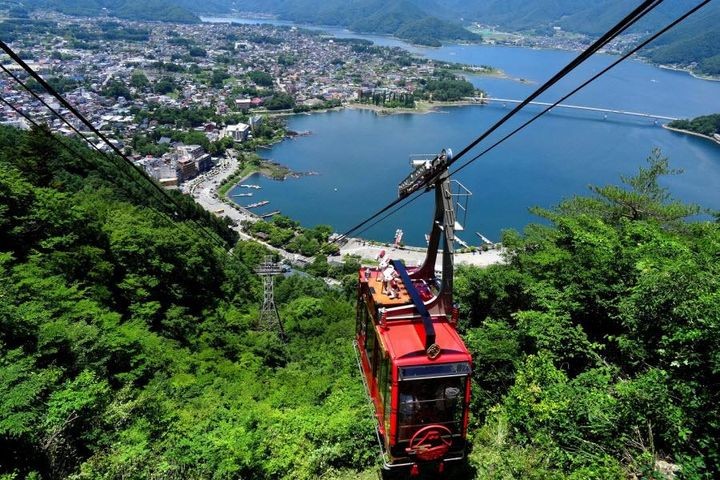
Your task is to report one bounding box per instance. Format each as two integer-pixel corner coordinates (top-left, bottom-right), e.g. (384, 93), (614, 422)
(11, 0), (200, 23)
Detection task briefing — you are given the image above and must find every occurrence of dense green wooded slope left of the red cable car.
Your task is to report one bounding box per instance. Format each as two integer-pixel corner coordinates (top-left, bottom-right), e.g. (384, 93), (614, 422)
(0, 128), (374, 480)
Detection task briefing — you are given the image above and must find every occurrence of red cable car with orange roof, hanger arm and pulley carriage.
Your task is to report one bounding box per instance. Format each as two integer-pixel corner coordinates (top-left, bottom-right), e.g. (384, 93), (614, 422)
(356, 151), (472, 476)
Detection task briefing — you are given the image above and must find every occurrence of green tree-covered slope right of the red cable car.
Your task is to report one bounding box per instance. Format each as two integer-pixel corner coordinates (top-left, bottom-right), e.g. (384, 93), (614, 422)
(455, 149), (720, 480)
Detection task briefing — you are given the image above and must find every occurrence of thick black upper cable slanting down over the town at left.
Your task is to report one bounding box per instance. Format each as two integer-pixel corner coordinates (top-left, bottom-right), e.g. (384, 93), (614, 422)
(0, 40), (226, 248)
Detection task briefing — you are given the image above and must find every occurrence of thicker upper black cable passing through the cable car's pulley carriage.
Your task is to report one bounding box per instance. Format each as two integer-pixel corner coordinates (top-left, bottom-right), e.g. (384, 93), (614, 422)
(336, 0), (663, 242)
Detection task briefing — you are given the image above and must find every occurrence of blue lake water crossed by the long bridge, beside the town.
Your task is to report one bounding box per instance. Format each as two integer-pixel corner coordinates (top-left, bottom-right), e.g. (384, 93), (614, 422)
(207, 19), (720, 245)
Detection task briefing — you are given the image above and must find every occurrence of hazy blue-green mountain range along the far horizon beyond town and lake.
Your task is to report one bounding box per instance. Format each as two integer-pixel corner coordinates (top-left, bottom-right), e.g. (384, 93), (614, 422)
(12, 0), (720, 75)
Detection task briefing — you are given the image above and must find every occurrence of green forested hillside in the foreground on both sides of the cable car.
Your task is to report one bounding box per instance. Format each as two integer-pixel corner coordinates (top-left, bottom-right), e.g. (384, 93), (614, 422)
(0, 123), (720, 480)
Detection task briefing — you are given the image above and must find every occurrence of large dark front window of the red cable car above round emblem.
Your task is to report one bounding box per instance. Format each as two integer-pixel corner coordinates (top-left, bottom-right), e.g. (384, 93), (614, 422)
(397, 376), (467, 442)
